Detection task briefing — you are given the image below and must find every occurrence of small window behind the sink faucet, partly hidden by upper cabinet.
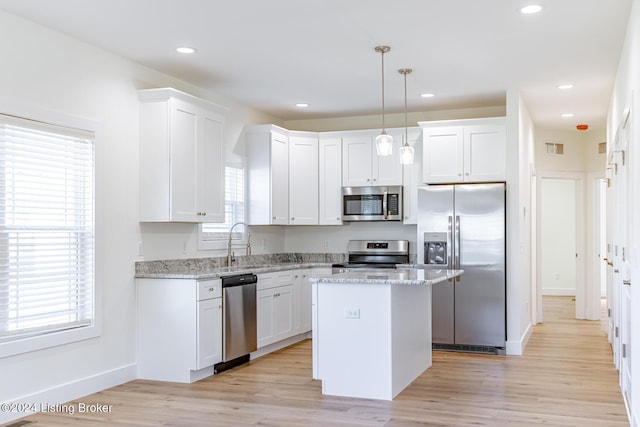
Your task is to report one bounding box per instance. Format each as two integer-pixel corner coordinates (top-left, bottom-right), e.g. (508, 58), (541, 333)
(199, 165), (245, 249)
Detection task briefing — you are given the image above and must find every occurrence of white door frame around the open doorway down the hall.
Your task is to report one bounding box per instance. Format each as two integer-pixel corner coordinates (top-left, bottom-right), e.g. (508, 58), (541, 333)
(534, 171), (599, 322)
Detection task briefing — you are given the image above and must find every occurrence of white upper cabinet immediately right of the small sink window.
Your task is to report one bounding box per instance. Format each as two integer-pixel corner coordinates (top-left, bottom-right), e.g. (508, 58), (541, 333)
(246, 125), (290, 225)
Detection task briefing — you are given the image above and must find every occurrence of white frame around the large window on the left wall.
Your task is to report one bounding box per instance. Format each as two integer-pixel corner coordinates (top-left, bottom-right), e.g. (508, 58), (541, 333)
(0, 97), (102, 359)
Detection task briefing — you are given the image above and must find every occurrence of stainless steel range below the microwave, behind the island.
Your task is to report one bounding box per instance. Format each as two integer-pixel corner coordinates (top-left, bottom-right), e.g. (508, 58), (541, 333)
(332, 240), (409, 273)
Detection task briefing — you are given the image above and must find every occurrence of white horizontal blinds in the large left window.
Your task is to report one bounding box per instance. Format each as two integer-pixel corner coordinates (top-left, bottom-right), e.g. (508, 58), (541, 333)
(0, 115), (94, 343)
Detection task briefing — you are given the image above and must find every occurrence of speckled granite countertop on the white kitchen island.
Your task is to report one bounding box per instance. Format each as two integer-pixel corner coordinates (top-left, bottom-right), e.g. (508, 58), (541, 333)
(309, 268), (463, 285)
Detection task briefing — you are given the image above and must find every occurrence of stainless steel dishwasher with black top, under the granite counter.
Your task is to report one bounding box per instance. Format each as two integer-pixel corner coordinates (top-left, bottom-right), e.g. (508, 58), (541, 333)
(214, 273), (258, 372)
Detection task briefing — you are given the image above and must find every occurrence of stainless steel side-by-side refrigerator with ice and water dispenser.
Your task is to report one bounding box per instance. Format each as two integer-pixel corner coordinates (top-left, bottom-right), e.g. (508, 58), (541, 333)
(417, 183), (506, 353)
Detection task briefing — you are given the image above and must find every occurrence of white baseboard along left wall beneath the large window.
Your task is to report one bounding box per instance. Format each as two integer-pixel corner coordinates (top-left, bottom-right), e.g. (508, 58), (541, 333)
(0, 363), (136, 424)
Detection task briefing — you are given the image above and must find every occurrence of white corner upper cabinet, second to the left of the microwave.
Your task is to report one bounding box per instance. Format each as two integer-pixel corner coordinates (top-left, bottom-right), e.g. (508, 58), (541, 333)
(289, 132), (318, 225)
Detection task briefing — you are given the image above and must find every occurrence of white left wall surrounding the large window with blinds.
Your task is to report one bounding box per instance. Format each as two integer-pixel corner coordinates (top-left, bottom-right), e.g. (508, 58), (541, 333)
(0, 11), (284, 423)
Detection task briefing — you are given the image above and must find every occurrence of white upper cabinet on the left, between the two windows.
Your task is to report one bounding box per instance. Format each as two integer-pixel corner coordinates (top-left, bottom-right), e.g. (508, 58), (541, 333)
(138, 88), (225, 222)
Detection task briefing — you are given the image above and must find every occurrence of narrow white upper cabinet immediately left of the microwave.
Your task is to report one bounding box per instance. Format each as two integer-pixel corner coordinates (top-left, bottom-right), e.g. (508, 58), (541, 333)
(318, 134), (342, 225)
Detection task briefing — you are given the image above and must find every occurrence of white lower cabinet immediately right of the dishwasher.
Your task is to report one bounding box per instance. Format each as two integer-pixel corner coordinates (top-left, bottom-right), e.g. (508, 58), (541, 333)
(256, 271), (294, 348)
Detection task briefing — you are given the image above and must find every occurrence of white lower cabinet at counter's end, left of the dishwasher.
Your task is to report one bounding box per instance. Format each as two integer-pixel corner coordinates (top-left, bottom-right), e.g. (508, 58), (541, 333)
(136, 279), (222, 383)
